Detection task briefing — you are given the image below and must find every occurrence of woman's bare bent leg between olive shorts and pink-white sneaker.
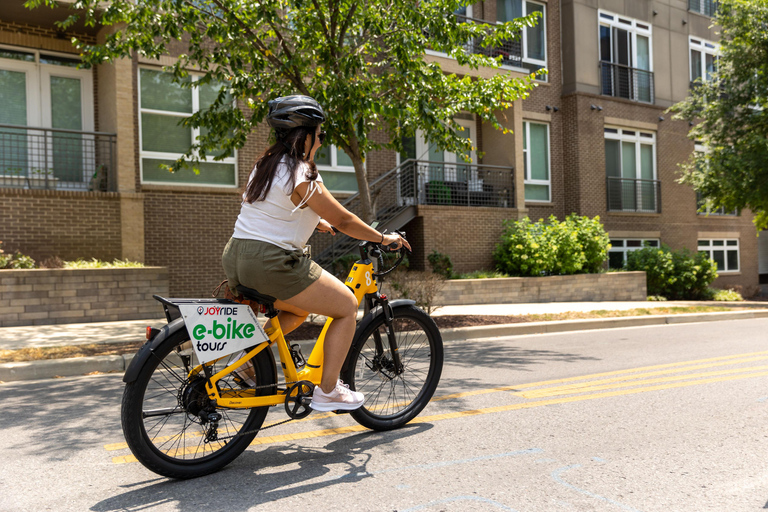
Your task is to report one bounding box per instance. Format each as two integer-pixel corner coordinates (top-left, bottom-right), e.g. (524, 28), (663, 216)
(276, 270), (358, 393)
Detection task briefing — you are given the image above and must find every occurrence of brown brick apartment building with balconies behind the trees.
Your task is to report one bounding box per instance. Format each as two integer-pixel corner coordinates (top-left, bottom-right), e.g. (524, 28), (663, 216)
(0, 0), (756, 296)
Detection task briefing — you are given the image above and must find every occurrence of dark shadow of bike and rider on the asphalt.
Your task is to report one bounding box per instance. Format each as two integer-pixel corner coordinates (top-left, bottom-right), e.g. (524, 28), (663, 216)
(90, 423), (432, 512)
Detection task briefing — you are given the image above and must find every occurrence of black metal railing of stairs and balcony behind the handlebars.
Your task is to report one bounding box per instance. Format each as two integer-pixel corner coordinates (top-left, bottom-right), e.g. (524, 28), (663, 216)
(309, 159), (515, 273)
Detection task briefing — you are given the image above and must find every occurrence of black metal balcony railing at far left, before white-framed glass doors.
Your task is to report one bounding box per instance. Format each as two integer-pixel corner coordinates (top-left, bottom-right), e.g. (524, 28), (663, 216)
(0, 124), (117, 191)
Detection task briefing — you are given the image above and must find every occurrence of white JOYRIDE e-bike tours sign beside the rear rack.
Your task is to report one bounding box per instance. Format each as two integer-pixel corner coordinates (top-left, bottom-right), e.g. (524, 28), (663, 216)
(178, 303), (269, 363)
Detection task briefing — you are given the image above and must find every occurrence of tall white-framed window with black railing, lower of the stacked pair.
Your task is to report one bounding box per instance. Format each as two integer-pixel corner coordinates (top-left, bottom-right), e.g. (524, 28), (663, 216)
(604, 127), (661, 213)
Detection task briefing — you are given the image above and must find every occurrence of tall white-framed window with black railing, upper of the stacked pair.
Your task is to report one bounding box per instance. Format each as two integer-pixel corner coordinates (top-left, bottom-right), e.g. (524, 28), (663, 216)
(598, 11), (654, 103)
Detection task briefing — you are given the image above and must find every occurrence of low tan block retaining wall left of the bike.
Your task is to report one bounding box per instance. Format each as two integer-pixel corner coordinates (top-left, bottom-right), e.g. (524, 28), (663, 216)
(0, 267), (168, 327)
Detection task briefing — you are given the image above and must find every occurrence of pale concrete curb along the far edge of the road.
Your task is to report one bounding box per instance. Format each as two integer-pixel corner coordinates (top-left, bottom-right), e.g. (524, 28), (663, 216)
(0, 310), (768, 382)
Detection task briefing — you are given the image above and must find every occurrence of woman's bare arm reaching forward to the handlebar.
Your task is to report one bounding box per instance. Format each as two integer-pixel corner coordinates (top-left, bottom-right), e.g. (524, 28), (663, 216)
(292, 182), (411, 250)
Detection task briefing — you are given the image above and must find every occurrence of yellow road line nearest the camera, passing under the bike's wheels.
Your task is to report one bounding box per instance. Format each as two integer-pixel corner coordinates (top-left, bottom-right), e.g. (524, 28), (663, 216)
(112, 372), (768, 464)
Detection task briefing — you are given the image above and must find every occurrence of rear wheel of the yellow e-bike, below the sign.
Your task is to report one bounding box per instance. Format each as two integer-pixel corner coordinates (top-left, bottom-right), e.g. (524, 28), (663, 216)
(121, 329), (277, 479)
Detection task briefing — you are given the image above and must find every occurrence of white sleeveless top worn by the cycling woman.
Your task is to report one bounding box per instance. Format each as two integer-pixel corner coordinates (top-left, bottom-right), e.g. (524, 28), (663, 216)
(232, 157), (323, 250)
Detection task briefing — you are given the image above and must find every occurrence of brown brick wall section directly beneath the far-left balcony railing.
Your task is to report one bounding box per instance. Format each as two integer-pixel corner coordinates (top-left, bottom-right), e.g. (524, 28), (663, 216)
(0, 188), (122, 261)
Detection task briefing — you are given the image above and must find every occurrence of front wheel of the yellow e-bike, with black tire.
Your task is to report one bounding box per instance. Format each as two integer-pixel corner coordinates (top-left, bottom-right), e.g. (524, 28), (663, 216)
(342, 304), (443, 431)
